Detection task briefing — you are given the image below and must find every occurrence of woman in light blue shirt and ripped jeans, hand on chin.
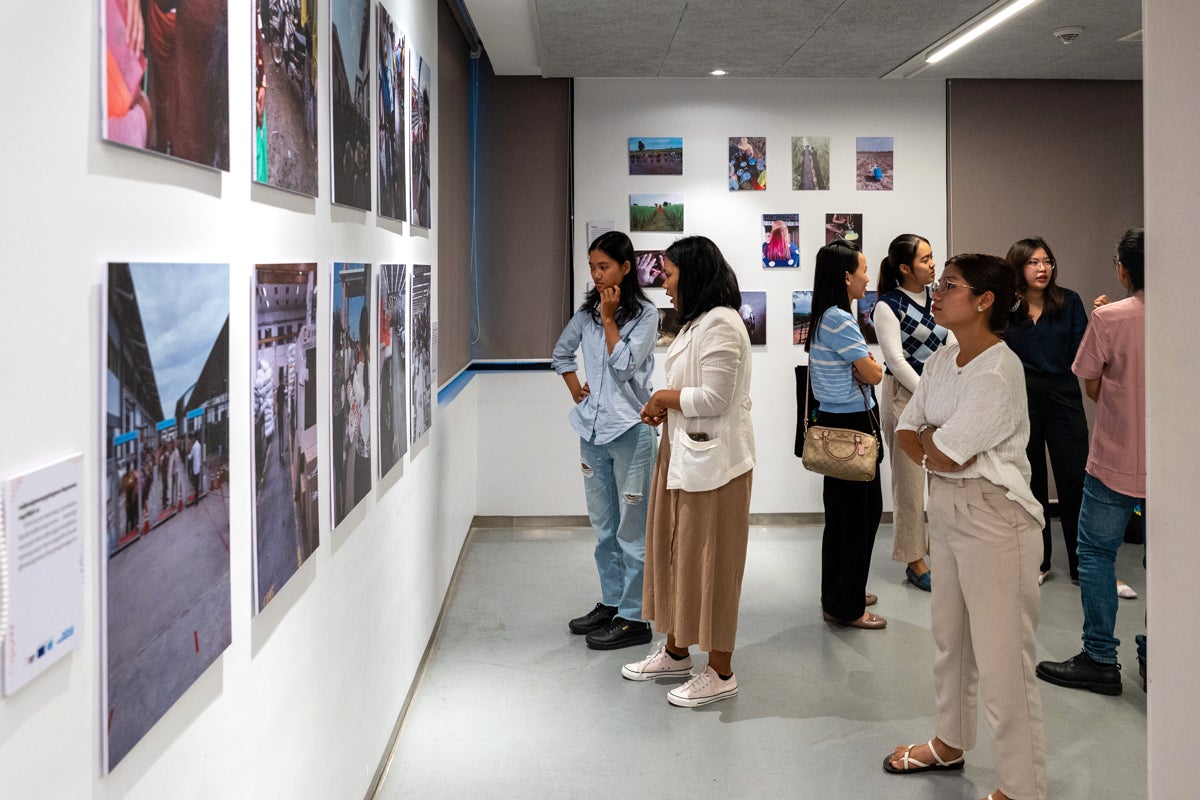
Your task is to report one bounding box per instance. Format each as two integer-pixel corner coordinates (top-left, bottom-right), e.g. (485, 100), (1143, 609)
(553, 230), (659, 650)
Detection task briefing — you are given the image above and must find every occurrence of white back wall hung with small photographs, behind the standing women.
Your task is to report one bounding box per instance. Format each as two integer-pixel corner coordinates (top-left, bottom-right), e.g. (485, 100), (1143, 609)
(479, 78), (947, 515)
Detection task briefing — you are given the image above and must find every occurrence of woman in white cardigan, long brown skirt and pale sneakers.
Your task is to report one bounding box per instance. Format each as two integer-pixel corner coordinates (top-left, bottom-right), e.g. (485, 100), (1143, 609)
(622, 236), (755, 706)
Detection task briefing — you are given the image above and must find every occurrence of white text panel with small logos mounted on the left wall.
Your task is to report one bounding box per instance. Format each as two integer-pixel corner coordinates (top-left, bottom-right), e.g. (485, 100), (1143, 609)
(0, 456), (83, 697)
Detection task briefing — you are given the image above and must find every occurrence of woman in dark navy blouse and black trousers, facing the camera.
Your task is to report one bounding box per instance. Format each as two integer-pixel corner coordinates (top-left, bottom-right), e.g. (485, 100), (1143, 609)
(1004, 236), (1087, 584)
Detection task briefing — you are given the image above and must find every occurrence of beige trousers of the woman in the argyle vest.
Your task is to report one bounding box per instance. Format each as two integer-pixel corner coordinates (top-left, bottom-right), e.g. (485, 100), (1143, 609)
(880, 374), (929, 564)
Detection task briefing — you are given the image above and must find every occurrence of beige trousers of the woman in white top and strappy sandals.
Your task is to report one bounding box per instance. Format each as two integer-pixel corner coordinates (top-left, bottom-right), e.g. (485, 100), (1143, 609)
(929, 475), (1046, 800)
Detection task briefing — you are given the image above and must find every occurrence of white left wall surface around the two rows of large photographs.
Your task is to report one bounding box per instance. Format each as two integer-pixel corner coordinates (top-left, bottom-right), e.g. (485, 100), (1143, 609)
(0, 0), (476, 800)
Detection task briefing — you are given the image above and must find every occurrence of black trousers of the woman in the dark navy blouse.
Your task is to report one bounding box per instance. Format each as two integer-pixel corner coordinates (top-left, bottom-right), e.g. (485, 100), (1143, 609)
(1025, 372), (1087, 578)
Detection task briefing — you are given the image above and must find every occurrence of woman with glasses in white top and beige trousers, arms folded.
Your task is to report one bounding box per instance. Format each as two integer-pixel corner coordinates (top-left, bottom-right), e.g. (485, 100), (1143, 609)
(883, 253), (1046, 800)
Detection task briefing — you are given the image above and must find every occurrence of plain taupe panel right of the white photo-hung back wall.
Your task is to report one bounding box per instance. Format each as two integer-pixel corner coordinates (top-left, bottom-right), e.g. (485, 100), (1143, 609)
(937, 80), (1144, 308)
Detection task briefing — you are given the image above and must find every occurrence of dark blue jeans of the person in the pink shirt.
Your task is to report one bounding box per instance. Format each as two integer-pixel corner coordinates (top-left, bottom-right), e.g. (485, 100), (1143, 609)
(1079, 475), (1145, 664)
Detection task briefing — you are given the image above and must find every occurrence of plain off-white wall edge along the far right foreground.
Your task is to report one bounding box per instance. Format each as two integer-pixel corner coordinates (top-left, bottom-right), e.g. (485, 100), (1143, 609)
(1142, 0), (1200, 800)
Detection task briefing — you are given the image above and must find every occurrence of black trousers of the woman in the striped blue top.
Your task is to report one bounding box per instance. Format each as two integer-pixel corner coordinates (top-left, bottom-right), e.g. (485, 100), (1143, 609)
(817, 410), (883, 622)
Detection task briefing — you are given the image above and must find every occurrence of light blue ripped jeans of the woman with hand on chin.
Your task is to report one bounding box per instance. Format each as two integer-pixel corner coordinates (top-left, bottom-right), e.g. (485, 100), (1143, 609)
(580, 422), (658, 621)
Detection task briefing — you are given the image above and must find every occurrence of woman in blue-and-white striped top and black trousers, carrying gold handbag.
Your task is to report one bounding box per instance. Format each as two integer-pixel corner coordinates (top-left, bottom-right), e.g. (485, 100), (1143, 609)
(804, 239), (888, 630)
